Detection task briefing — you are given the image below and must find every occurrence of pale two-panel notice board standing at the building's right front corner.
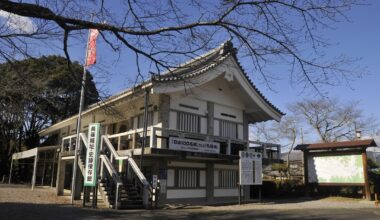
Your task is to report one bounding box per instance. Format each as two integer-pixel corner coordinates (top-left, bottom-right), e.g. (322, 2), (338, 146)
(239, 151), (262, 185)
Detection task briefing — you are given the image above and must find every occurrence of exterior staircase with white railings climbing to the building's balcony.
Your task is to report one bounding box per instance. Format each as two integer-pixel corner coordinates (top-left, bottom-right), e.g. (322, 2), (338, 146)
(78, 133), (151, 209)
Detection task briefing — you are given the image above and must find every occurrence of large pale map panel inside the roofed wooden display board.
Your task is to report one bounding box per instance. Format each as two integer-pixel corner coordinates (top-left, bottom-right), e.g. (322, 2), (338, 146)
(307, 155), (364, 184)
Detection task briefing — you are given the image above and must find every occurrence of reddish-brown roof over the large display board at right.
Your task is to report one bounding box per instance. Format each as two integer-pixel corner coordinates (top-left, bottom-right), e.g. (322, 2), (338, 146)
(294, 139), (377, 150)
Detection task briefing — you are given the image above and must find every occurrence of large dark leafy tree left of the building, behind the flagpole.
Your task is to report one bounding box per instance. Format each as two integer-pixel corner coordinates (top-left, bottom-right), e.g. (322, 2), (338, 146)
(0, 56), (99, 177)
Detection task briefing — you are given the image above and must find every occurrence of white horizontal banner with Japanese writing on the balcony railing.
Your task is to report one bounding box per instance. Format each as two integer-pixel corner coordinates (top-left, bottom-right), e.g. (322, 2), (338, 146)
(169, 137), (220, 154)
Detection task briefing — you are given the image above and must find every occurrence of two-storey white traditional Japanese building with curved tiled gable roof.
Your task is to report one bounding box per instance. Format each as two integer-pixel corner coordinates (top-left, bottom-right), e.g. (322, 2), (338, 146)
(14, 42), (283, 208)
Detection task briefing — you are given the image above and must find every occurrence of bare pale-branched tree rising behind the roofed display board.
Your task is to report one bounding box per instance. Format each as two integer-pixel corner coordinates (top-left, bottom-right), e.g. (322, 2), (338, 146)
(290, 98), (378, 142)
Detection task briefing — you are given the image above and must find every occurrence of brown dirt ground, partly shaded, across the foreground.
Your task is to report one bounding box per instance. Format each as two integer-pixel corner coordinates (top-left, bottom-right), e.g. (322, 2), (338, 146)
(0, 184), (380, 220)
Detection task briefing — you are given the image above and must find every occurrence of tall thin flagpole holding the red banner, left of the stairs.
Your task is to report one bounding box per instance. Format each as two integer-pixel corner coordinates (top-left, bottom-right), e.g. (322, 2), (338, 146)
(71, 26), (92, 205)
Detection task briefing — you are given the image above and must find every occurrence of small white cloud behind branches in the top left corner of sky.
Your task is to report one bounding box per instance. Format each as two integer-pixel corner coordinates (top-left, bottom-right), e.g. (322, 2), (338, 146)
(0, 10), (36, 34)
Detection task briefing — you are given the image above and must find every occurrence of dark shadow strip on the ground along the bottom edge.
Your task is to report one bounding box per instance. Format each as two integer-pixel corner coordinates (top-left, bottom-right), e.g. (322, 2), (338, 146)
(0, 203), (380, 220)
